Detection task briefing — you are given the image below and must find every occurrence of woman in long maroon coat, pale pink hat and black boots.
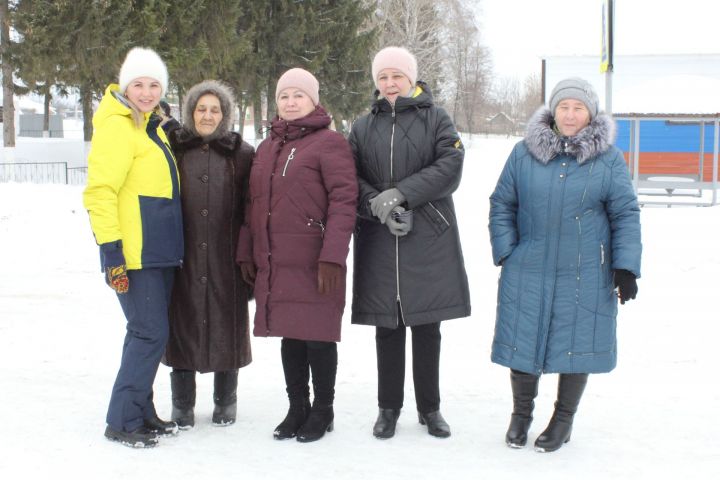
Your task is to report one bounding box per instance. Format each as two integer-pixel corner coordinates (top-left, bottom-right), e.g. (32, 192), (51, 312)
(236, 68), (358, 442)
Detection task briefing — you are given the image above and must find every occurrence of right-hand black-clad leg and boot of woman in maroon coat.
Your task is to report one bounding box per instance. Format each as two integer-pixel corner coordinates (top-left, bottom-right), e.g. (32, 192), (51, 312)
(297, 342), (337, 442)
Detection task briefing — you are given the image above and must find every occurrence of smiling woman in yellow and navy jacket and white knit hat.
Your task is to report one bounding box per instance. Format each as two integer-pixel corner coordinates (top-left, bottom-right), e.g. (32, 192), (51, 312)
(83, 48), (183, 447)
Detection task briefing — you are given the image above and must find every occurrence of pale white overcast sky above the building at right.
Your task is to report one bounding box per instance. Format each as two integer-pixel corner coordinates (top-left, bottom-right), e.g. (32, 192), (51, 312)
(476, 0), (720, 78)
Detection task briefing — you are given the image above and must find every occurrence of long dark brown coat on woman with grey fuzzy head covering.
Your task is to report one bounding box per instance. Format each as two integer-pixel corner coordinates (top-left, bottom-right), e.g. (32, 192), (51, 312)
(163, 129), (253, 372)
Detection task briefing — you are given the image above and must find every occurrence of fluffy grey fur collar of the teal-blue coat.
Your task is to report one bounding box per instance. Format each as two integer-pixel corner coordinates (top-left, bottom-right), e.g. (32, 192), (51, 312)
(525, 107), (615, 164)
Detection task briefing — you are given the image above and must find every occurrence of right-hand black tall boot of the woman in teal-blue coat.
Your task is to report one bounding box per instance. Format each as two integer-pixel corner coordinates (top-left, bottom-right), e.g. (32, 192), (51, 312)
(535, 373), (588, 452)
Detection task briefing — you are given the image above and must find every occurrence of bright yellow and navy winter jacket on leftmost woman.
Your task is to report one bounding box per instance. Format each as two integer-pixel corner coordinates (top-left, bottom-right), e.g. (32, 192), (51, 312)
(83, 84), (183, 270)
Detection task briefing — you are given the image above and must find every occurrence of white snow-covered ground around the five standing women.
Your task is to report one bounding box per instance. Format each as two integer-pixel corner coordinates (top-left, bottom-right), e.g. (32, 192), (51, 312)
(0, 137), (720, 480)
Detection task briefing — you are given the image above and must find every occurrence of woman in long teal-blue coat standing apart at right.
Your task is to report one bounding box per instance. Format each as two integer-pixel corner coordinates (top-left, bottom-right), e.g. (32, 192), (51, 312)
(490, 78), (642, 451)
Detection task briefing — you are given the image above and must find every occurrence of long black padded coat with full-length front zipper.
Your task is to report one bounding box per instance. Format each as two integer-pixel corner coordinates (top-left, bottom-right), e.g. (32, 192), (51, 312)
(350, 82), (470, 328)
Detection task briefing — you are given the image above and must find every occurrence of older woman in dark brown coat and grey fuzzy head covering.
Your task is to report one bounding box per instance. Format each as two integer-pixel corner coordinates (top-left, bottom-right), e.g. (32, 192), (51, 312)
(165, 80), (253, 428)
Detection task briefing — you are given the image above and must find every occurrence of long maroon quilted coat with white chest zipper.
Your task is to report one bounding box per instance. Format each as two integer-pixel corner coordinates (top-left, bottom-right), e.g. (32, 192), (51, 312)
(236, 106), (358, 342)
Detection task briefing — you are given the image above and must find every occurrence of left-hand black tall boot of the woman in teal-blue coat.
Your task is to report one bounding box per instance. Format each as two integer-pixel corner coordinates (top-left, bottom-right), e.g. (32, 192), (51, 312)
(505, 370), (540, 448)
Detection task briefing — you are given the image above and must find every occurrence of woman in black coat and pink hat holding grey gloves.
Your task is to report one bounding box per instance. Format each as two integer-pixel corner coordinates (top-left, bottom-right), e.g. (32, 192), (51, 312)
(350, 47), (470, 438)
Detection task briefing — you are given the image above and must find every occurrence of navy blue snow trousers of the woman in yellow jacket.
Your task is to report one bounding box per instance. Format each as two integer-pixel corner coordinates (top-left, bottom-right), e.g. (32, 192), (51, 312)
(107, 267), (175, 432)
